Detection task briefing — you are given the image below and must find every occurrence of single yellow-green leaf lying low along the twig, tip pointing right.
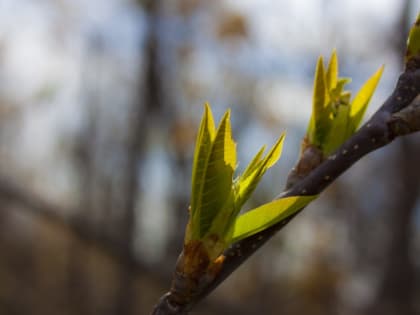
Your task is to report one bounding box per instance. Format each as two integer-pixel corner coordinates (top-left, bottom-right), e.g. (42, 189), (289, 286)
(228, 196), (317, 243)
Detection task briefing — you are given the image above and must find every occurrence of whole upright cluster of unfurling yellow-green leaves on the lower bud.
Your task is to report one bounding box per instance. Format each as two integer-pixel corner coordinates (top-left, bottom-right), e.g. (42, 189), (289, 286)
(184, 104), (314, 262)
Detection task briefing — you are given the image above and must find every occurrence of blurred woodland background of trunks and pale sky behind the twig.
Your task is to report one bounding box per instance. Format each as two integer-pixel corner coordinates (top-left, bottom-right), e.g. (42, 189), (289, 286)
(0, 0), (420, 315)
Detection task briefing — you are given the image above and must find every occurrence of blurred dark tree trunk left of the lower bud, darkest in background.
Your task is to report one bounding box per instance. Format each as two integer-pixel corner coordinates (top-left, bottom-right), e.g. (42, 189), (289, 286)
(115, 1), (163, 315)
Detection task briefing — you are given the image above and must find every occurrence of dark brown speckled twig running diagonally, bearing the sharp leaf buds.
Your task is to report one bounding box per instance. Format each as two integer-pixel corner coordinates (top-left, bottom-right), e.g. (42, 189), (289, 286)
(152, 57), (420, 315)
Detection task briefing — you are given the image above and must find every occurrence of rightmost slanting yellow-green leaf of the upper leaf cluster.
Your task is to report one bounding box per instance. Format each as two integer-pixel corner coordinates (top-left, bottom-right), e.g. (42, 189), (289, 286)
(349, 66), (384, 134)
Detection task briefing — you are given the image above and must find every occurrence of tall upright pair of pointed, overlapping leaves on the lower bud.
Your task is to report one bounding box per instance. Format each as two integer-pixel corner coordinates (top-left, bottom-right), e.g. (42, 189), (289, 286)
(191, 104), (236, 239)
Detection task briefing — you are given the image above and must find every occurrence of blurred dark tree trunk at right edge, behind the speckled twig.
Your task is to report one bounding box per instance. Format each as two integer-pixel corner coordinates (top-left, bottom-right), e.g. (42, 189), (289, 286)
(367, 0), (420, 315)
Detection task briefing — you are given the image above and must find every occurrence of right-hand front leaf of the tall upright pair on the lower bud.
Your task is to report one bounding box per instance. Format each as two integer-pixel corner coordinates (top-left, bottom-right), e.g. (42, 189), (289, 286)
(195, 111), (236, 236)
